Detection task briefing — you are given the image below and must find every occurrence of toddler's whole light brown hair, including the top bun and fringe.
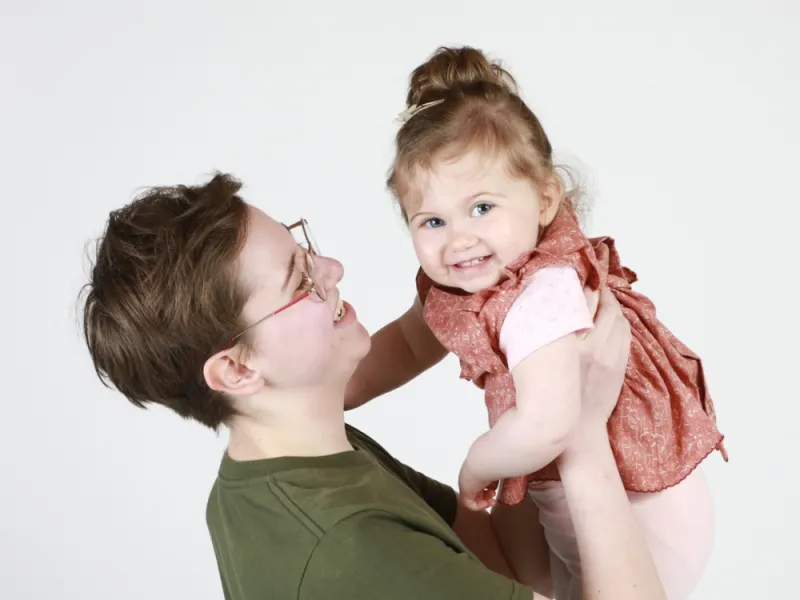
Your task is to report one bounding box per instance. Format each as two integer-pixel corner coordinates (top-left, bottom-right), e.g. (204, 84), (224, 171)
(386, 46), (577, 221)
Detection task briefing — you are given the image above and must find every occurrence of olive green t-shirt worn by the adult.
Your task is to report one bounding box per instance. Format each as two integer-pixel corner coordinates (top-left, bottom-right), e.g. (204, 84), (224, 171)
(206, 427), (532, 600)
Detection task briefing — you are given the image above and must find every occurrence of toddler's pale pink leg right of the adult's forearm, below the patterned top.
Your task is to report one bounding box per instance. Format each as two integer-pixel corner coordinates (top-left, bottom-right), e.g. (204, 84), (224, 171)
(628, 469), (714, 600)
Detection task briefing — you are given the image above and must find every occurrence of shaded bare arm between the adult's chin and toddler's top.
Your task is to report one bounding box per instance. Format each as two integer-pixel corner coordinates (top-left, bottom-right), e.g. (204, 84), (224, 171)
(345, 298), (447, 409)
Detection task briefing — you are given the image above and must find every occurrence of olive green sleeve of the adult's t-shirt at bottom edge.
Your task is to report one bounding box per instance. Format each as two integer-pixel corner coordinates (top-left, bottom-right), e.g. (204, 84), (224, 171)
(298, 511), (533, 600)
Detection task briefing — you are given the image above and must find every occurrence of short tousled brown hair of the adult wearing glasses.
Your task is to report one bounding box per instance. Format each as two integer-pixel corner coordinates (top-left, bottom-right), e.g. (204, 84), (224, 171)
(83, 174), (248, 430)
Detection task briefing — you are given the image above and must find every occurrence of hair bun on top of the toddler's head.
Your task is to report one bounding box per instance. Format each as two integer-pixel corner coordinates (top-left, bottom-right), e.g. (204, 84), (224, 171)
(406, 46), (518, 106)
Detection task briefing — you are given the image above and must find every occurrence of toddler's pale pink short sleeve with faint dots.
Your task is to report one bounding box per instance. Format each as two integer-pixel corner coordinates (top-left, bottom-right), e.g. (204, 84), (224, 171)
(500, 266), (593, 370)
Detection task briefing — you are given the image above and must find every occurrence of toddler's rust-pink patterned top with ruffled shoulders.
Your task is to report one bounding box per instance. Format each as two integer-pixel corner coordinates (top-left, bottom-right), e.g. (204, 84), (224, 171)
(417, 204), (727, 504)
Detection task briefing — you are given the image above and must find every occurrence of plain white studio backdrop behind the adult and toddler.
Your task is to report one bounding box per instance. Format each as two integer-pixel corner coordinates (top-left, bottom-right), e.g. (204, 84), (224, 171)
(0, 0), (800, 600)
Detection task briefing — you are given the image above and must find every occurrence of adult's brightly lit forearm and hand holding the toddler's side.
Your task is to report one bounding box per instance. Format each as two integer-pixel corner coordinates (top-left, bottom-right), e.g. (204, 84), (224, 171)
(557, 289), (666, 600)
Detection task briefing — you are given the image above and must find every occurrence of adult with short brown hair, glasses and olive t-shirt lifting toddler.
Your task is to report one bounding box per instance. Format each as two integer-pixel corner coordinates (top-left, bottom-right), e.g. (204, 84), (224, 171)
(84, 175), (663, 600)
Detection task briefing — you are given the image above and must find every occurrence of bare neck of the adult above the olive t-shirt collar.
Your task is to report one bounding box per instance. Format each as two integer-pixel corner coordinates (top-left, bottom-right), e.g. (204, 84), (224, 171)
(223, 390), (353, 461)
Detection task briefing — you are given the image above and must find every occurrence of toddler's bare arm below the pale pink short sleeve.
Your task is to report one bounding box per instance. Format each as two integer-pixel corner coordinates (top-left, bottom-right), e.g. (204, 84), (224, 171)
(460, 334), (581, 498)
